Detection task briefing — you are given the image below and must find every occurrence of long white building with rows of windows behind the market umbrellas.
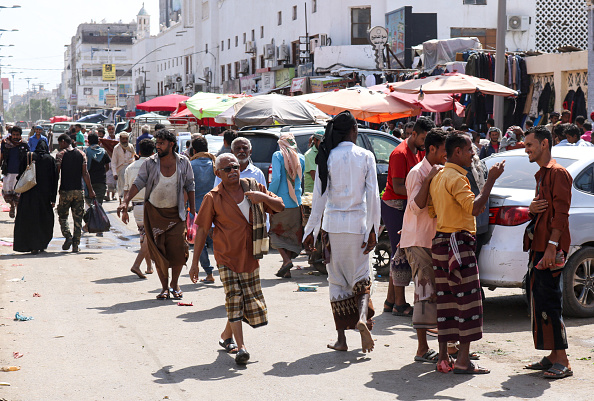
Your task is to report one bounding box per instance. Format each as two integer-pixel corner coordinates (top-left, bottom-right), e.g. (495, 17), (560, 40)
(128, 0), (588, 98)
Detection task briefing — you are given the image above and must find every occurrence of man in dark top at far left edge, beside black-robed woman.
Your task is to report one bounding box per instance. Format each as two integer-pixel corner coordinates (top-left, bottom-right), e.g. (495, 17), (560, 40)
(0, 125), (28, 219)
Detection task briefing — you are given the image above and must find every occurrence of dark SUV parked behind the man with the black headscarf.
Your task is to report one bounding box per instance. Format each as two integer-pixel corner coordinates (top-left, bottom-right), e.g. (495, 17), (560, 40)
(239, 125), (401, 192)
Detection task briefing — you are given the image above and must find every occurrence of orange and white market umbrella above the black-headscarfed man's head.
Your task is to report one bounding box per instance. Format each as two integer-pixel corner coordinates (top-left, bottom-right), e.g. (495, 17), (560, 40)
(306, 87), (420, 123)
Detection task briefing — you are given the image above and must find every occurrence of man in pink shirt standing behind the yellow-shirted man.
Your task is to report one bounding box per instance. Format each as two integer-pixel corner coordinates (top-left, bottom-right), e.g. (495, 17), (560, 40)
(400, 128), (446, 363)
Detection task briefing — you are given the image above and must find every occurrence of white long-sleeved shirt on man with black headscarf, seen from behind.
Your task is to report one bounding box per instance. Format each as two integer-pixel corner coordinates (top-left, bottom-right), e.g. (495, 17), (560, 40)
(303, 142), (381, 240)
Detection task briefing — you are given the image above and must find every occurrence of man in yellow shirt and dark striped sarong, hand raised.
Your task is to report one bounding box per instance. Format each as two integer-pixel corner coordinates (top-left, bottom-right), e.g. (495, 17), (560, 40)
(429, 132), (505, 374)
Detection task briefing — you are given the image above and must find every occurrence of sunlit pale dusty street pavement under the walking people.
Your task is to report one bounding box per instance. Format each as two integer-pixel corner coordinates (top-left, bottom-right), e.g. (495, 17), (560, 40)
(0, 202), (594, 401)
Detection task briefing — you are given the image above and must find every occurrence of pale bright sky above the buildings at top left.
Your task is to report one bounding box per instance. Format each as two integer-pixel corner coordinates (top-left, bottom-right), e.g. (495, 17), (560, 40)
(0, 0), (159, 95)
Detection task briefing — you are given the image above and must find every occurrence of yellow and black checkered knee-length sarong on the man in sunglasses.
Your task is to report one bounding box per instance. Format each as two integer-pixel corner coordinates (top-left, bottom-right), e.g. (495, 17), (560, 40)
(219, 266), (268, 328)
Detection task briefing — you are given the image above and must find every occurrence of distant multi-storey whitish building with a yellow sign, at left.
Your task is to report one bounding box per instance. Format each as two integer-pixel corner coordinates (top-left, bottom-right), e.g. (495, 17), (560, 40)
(59, 17), (138, 113)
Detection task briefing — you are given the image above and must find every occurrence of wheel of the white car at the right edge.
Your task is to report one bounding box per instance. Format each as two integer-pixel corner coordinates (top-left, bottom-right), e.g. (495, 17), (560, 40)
(563, 247), (594, 317)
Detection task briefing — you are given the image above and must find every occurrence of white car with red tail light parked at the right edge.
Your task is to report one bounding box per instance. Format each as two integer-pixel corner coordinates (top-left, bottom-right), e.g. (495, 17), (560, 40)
(479, 146), (594, 317)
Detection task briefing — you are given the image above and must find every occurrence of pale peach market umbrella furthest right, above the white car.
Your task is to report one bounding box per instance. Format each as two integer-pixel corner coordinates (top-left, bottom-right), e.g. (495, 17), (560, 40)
(389, 73), (518, 96)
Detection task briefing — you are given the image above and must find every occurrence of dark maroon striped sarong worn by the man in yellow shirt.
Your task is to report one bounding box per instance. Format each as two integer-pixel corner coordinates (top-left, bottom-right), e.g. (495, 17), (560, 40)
(431, 231), (483, 343)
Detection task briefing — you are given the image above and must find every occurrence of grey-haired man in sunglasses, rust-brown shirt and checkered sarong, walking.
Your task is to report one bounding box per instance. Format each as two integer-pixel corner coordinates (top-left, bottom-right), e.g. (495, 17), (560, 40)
(190, 153), (284, 364)
